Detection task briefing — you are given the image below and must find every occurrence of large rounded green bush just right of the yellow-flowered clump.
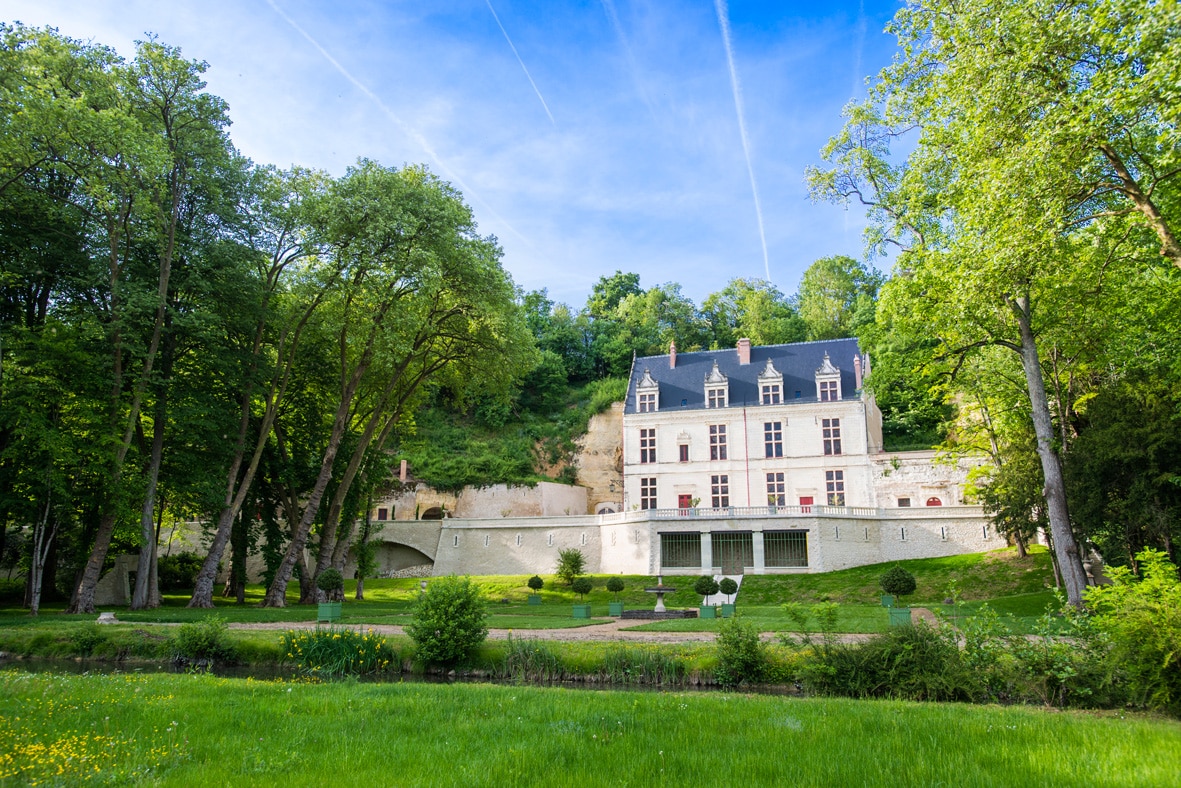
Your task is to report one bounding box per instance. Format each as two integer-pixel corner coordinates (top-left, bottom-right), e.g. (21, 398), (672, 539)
(406, 575), (488, 664)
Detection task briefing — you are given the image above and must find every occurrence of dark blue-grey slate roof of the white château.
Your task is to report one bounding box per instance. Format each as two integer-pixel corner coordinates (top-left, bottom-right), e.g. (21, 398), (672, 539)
(624, 339), (861, 413)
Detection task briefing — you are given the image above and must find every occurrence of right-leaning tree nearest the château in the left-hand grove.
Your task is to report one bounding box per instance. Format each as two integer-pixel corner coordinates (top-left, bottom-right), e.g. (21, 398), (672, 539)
(263, 161), (531, 607)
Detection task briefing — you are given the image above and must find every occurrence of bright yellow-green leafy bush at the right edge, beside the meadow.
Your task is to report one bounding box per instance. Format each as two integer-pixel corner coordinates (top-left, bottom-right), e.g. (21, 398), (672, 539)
(1087, 549), (1181, 714)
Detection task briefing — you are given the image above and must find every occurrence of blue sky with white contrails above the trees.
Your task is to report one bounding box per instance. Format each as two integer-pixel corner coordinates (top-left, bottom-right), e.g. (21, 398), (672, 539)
(0, 0), (899, 307)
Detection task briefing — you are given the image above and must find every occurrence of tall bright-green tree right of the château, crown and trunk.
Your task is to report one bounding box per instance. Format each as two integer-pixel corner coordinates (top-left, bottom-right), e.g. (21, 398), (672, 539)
(809, 0), (1181, 605)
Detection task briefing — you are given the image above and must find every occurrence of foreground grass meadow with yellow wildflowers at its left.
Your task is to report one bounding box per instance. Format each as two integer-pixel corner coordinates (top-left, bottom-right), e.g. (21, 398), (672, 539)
(0, 671), (1181, 786)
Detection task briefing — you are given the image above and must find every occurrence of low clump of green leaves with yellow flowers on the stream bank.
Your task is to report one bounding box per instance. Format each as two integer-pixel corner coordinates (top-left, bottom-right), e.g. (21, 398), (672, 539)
(279, 626), (402, 676)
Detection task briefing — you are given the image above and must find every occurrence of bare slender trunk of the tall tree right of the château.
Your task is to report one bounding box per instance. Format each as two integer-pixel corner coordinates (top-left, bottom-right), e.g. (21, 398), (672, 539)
(1007, 295), (1087, 607)
